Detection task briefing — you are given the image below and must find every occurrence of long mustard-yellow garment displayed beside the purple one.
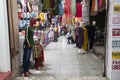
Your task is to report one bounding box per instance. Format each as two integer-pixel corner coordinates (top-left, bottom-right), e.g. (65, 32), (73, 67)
(82, 25), (88, 50)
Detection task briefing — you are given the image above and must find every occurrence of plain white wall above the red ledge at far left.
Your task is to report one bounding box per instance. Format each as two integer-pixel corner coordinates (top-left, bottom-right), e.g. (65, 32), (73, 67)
(0, 0), (11, 72)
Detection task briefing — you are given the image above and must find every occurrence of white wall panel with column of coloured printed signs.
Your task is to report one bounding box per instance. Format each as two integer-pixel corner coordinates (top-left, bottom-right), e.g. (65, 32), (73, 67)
(106, 0), (120, 80)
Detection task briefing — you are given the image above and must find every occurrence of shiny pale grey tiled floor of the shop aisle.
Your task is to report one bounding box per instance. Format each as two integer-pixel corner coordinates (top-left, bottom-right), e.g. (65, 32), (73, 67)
(19, 37), (108, 80)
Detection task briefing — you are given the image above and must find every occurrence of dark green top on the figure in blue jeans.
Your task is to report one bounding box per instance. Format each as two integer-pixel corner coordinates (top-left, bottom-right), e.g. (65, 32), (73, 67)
(24, 27), (34, 47)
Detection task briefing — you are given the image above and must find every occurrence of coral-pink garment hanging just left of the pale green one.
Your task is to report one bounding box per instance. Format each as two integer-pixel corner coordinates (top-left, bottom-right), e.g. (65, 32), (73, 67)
(64, 0), (71, 17)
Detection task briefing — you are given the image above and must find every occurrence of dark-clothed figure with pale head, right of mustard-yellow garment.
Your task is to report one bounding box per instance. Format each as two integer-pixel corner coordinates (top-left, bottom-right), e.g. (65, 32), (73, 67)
(89, 21), (96, 51)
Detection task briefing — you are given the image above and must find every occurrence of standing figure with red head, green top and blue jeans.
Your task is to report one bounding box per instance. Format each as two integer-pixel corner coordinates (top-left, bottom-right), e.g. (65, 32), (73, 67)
(23, 18), (36, 77)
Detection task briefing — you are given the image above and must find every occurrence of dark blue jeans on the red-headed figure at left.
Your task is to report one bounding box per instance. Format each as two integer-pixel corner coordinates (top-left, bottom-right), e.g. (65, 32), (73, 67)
(23, 47), (32, 72)
